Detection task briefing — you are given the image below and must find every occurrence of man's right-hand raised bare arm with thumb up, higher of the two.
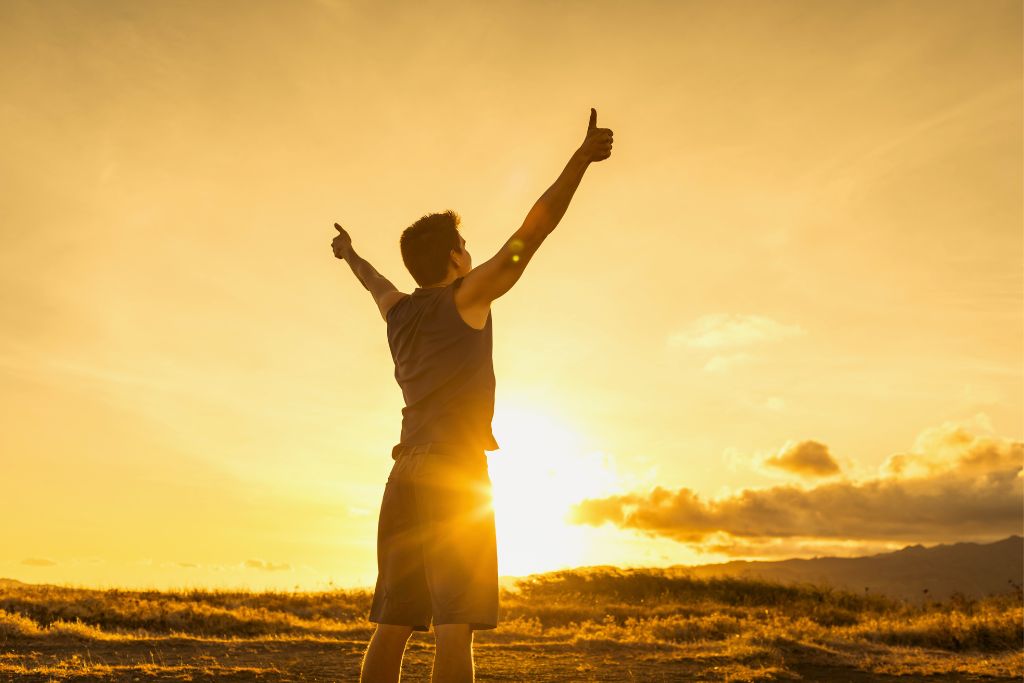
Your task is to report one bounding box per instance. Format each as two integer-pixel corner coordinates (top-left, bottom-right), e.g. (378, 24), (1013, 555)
(456, 109), (612, 319)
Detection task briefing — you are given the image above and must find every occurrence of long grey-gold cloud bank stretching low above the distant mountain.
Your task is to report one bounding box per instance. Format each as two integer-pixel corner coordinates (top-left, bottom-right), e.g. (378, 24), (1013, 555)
(571, 423), (1024, 545)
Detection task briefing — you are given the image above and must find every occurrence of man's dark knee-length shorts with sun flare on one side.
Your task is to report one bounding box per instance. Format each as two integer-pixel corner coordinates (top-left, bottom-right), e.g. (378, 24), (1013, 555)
(369, 451), (498, 631)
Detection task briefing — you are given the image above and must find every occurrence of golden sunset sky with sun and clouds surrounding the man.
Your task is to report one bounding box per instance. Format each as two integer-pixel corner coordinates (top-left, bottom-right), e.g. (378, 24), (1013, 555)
(0, 0), (1024, 589)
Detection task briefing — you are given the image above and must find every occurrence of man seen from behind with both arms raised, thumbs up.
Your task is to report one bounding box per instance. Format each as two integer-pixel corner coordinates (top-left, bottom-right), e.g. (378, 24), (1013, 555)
(332, 109), (612, 683)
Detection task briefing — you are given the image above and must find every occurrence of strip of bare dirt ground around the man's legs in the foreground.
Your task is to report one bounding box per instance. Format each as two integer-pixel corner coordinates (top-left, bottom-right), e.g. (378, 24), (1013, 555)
(0, 637), (1018, 683)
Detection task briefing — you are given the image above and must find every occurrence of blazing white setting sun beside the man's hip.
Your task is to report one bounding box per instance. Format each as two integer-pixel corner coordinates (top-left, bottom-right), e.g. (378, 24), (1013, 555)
(487, 409), (617, 575)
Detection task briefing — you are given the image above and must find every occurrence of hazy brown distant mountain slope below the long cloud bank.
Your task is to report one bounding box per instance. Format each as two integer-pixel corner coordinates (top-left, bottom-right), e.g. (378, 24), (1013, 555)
(673, 536), (1024, 600)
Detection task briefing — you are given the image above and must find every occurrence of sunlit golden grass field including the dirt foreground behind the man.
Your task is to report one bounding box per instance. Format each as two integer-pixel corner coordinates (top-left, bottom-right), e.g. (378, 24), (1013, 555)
(0, 568), (1024, 682)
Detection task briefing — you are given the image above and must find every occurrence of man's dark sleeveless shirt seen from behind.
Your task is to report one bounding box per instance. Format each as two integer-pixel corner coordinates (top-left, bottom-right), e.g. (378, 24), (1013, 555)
(387, 278), (499, 451)
